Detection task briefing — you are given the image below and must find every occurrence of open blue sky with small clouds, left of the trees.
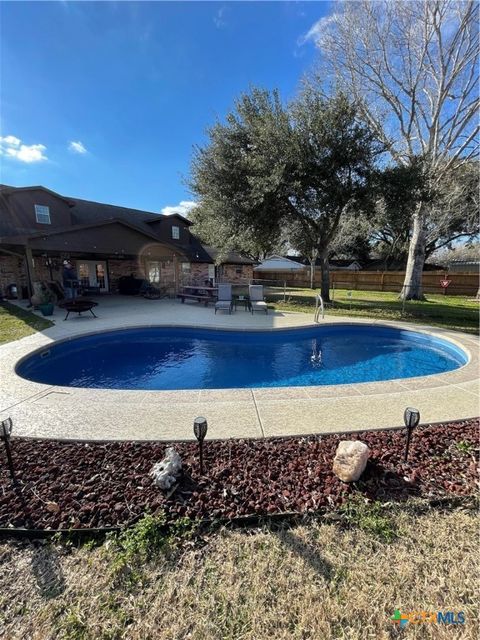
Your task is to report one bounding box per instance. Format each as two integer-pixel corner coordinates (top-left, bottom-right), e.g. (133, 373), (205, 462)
(0, 2), (330, 212)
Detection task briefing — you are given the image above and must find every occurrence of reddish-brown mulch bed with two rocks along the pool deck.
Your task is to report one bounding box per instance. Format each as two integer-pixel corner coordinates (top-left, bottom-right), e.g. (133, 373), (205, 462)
(0, 419), (479, 529)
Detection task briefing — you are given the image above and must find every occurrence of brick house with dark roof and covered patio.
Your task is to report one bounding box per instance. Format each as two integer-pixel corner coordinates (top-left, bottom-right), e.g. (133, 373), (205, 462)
(0, 185), (253, 298)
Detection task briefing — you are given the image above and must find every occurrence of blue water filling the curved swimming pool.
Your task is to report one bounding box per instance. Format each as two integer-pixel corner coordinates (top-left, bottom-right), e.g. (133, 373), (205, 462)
(17, 324), (467, 389)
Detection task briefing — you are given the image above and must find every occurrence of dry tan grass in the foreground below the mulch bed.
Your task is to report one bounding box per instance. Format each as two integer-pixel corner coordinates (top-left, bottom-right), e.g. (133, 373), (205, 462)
(0, 510), (478, 640)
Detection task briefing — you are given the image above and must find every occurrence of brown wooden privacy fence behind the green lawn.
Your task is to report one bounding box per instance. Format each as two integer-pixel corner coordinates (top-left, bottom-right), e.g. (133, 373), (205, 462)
(254, 270), (479, 296)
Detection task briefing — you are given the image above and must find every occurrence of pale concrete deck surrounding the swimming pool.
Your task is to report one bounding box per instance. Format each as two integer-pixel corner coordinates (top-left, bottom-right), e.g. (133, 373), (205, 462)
(0, 296), (480, 440)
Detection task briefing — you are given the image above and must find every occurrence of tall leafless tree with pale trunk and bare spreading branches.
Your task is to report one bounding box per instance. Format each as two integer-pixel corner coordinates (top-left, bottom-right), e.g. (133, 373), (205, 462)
(315, 0), (479, 299)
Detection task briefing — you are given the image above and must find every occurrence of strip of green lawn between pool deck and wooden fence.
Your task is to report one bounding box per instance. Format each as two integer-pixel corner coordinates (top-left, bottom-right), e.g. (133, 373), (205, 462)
(267, 289), (479, 335)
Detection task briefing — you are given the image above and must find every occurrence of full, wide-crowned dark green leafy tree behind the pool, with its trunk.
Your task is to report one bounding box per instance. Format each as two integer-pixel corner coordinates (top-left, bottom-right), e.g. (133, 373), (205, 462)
(190, 85), (379, 301)
